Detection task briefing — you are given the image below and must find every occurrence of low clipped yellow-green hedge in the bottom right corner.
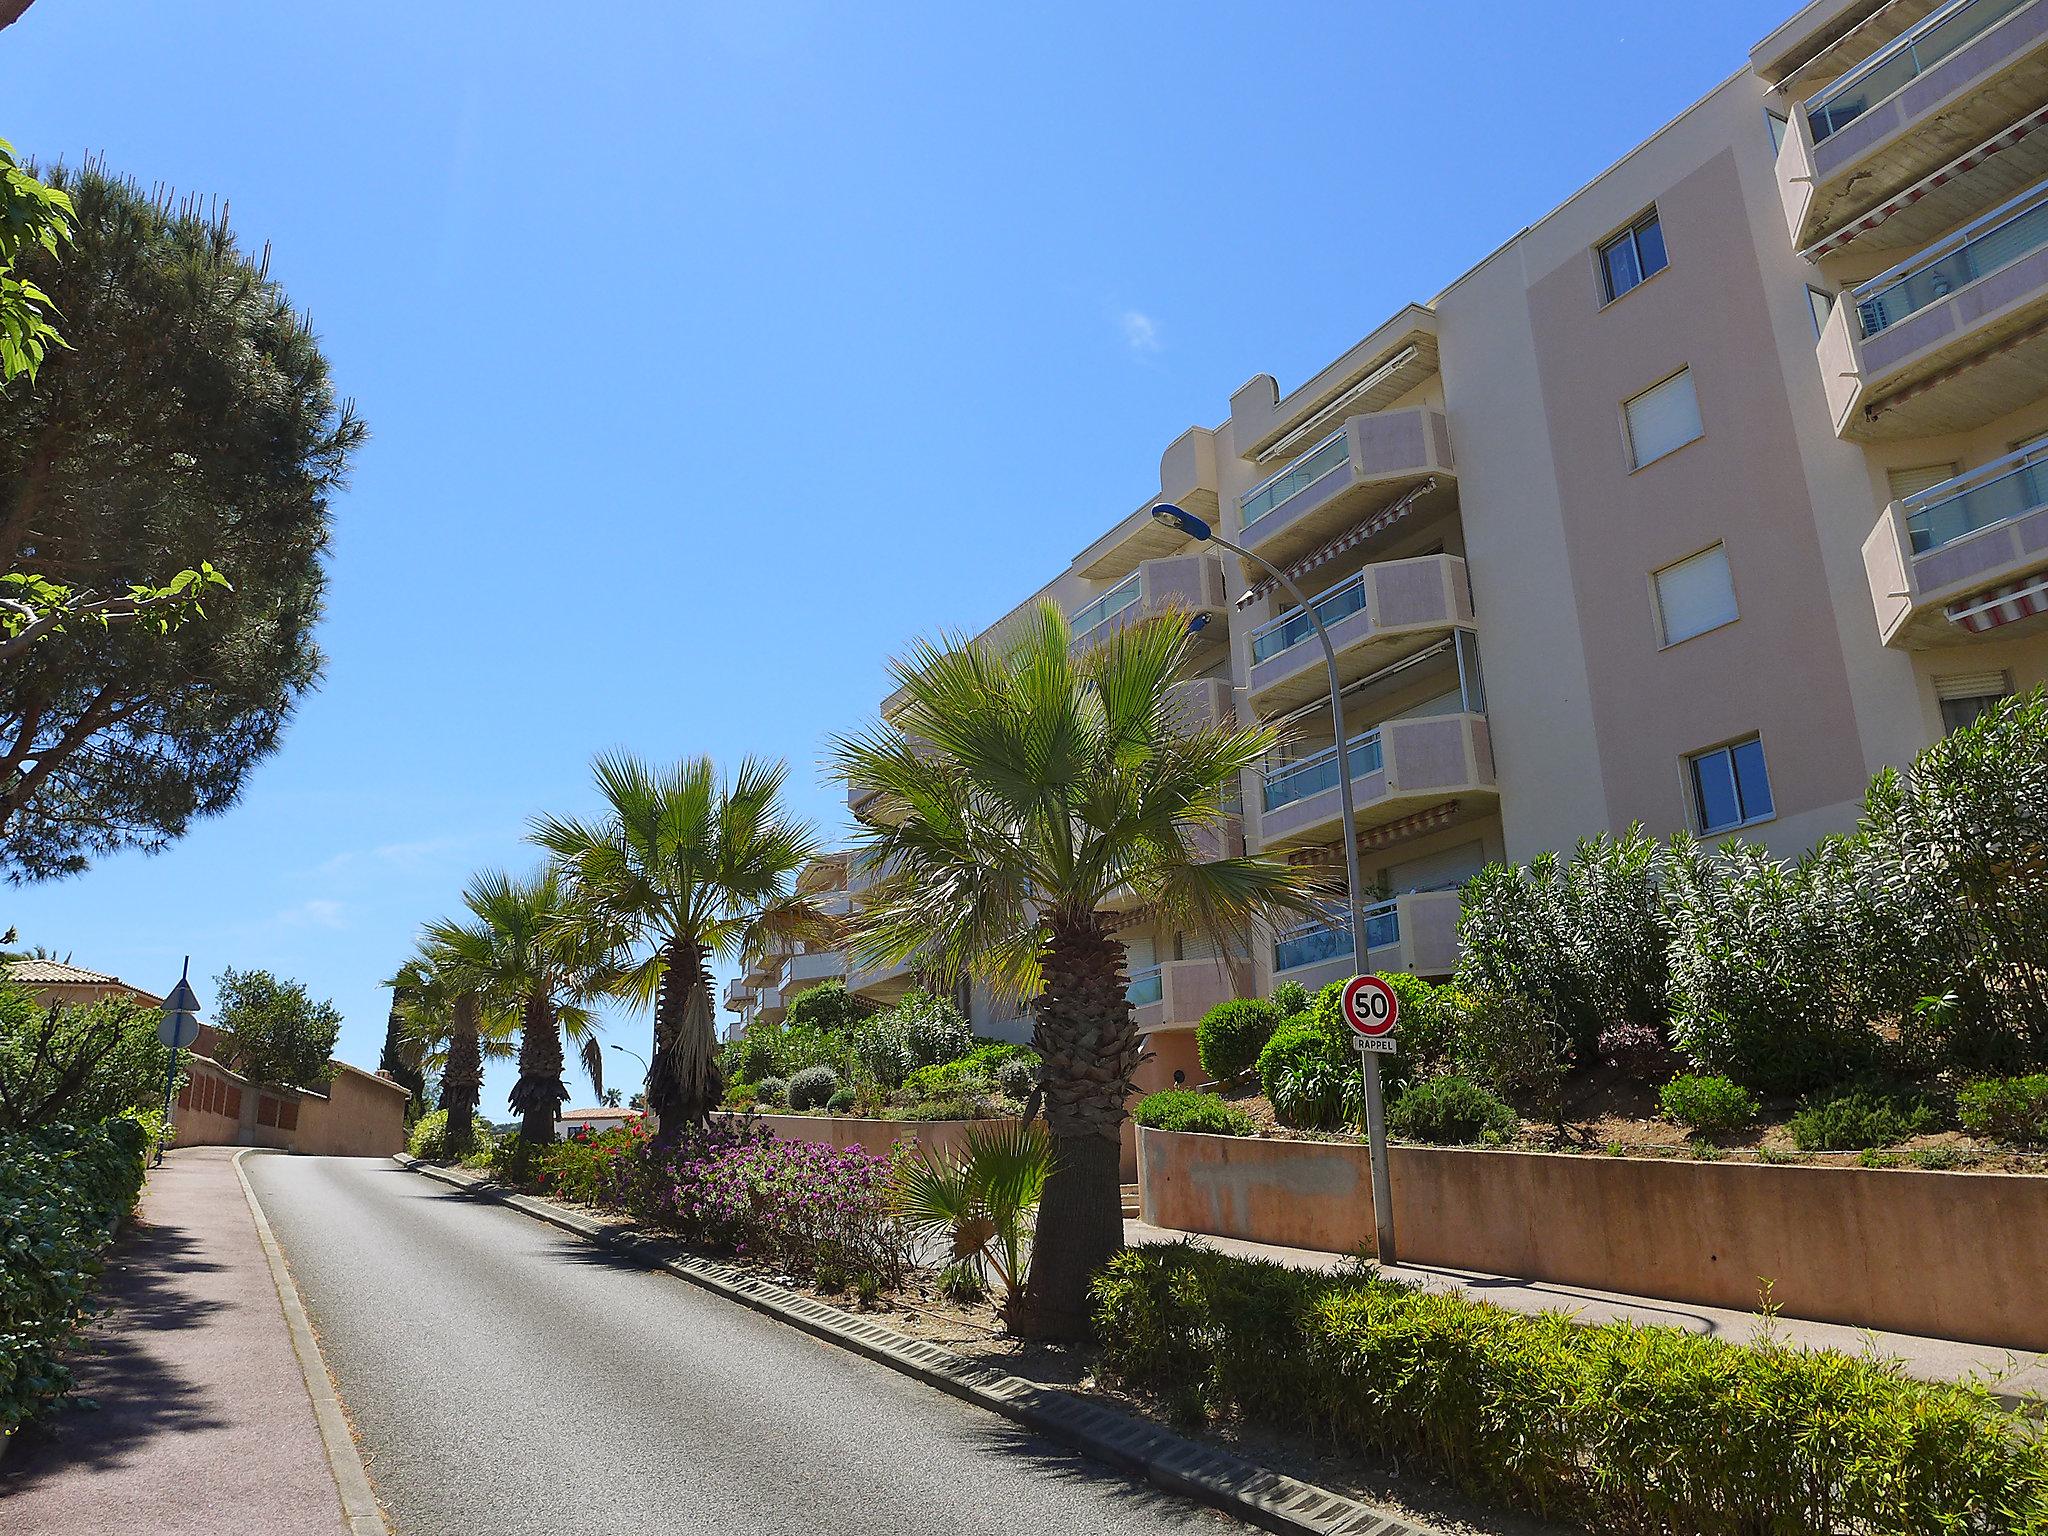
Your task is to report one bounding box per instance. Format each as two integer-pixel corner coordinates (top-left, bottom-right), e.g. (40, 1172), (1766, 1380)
(1094, 1243), (2048, 1536)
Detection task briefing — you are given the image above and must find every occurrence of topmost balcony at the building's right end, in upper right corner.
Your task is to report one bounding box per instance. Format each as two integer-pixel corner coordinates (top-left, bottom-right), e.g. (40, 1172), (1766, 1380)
(1778, 0), (2048, 250)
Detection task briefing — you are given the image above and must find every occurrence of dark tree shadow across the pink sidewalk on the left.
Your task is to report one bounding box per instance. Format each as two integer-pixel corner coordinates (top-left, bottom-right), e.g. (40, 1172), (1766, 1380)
(0, 1221), (221, 1490)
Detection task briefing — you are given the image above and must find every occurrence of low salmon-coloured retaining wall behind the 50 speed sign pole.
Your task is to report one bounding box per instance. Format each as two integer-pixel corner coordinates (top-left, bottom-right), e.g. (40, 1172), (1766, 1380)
(1139, 1130), (2048, 1350)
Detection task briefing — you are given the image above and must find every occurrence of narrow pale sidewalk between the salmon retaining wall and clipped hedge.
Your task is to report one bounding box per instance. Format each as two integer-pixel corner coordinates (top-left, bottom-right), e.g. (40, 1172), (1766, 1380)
(1124, 1221), (2048, 1403)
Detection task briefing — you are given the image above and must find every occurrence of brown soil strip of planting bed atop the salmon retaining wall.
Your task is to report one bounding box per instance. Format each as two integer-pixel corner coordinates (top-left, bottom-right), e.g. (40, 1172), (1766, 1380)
(1225, 1067), (2048, 1174)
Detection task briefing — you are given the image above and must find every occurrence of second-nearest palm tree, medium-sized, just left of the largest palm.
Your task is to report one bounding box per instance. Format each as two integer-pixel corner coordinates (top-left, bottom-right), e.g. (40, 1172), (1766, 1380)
(532, 754), (829, 1139)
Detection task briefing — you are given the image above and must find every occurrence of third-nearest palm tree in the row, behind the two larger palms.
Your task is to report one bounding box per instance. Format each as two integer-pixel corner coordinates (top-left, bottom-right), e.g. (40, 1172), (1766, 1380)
(428, 868), (604, 1145)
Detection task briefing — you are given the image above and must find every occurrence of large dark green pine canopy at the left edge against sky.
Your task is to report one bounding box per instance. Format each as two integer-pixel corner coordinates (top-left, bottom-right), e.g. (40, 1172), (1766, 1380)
(0, 166), (362, 881)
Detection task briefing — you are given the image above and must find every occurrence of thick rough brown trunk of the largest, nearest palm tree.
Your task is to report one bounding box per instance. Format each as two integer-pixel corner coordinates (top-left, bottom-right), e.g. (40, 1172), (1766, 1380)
(1012, 913), (1139, 1339)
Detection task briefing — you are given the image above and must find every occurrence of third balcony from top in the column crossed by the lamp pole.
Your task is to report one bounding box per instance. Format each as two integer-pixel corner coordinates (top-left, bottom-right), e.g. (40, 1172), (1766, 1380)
(1260, 713), (1497, 852)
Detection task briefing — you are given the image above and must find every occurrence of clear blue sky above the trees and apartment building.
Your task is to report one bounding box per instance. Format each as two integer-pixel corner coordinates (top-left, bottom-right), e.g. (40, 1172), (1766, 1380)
(0, 0), (1794, 1118)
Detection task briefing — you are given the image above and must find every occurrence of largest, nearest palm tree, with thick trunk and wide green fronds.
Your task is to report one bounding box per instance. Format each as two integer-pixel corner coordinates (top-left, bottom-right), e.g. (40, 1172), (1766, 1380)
(834, 604), (1317, 1337)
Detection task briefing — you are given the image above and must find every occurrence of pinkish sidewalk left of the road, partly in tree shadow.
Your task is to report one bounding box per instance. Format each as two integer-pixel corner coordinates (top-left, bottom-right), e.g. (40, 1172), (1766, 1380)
(0, 1147), (346, 1536)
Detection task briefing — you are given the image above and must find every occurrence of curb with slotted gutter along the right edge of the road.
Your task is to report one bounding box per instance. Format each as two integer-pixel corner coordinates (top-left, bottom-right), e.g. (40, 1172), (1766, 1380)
(393, 1153), (1438, 1536)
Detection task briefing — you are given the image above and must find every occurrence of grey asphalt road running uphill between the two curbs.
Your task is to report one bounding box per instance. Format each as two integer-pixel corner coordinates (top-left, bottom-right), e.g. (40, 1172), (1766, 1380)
(244, 1157), (1245, 1536)
